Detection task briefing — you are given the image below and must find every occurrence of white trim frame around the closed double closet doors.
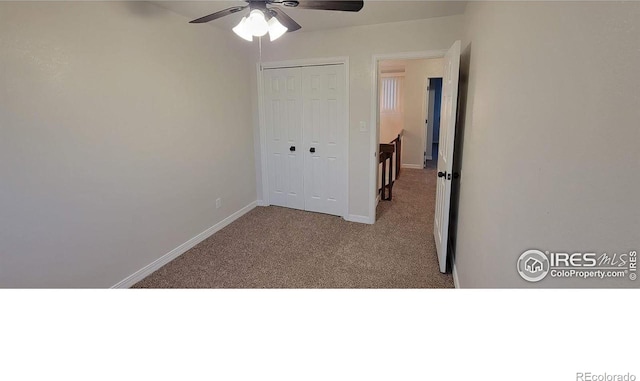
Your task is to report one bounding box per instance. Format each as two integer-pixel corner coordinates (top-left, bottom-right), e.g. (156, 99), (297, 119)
(256, 56), (350, 219)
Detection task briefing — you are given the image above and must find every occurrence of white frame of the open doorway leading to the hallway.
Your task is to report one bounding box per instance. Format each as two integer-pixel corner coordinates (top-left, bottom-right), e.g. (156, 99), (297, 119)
(369, 49), (447, 224)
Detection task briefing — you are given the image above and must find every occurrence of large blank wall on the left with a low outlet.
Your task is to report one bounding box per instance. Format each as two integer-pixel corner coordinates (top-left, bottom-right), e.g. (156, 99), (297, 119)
(0, 2), (256, 287)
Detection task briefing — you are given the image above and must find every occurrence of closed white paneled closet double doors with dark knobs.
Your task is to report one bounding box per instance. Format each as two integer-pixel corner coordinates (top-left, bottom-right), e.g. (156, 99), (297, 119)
(263, 65), (348, 216)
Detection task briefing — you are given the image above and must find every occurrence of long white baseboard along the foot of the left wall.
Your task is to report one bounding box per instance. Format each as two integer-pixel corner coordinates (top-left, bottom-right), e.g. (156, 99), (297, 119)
(111, 201), (258, 288)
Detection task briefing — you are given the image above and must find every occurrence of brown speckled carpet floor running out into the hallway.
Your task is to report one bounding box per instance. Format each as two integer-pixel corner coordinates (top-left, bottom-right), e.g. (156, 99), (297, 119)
(134, 164), (453, 288)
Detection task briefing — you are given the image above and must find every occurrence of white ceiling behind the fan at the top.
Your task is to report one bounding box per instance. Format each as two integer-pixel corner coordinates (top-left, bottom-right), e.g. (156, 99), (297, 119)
(152, 0), (467, 31)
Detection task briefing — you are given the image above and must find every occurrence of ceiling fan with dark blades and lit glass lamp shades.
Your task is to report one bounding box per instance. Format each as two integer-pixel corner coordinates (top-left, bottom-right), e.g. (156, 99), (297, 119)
(190, 0), (364, 41)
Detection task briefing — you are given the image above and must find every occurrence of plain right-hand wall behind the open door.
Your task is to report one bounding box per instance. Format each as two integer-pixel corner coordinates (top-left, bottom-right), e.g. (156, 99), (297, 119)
(456, 2), (640, 287)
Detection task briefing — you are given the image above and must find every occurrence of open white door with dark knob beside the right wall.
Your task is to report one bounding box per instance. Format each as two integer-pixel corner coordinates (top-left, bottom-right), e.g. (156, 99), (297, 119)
(433, 41), (460, 273)
